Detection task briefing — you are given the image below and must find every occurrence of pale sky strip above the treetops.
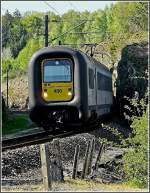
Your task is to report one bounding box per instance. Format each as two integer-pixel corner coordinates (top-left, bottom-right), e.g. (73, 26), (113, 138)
(1, 1), (117, 15)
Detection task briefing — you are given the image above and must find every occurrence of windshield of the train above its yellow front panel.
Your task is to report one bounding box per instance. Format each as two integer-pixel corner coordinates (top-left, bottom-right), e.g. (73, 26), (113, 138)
(43, 59), (72, 82)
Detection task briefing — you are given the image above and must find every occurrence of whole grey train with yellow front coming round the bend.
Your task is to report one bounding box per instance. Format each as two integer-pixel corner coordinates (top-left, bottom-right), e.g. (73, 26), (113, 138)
(28, 46), (113, 131)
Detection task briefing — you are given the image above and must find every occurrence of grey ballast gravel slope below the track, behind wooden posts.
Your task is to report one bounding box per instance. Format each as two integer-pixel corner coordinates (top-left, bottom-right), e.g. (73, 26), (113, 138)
(2, 122), (129, 185)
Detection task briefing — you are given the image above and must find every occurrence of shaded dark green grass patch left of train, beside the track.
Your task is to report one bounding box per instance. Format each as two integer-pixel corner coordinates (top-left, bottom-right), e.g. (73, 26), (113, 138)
(2, 115), (35, 135)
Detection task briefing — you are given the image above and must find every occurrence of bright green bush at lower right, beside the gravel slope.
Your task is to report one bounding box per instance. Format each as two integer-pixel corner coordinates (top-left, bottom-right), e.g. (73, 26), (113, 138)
(123, 112), (148, 188)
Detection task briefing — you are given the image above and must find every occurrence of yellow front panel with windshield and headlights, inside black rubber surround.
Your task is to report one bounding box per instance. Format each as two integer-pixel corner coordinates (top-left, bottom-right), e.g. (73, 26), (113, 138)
(42, 58), (74, 102)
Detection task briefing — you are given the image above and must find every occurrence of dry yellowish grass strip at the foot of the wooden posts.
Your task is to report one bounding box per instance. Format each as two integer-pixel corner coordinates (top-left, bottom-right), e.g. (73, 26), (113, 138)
(3, 177), (148, 192)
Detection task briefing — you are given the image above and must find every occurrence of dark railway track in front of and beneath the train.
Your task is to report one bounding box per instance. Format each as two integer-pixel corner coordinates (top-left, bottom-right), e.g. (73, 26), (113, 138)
(2, 121), (101, 151)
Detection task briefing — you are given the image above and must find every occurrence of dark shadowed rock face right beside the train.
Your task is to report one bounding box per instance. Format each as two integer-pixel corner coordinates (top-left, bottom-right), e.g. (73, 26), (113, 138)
(116, 42), (148, 117)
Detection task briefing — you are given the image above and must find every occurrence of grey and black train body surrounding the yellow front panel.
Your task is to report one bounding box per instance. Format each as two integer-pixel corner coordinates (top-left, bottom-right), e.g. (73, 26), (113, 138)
(29, 46), (113, 127)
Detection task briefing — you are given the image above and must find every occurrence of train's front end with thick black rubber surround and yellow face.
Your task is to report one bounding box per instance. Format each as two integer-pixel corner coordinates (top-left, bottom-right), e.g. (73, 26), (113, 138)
(29, 48), (85, 130)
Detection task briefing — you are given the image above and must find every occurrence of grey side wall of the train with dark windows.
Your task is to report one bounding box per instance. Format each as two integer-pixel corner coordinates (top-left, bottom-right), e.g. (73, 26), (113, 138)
(81, 52), (113, 118)
